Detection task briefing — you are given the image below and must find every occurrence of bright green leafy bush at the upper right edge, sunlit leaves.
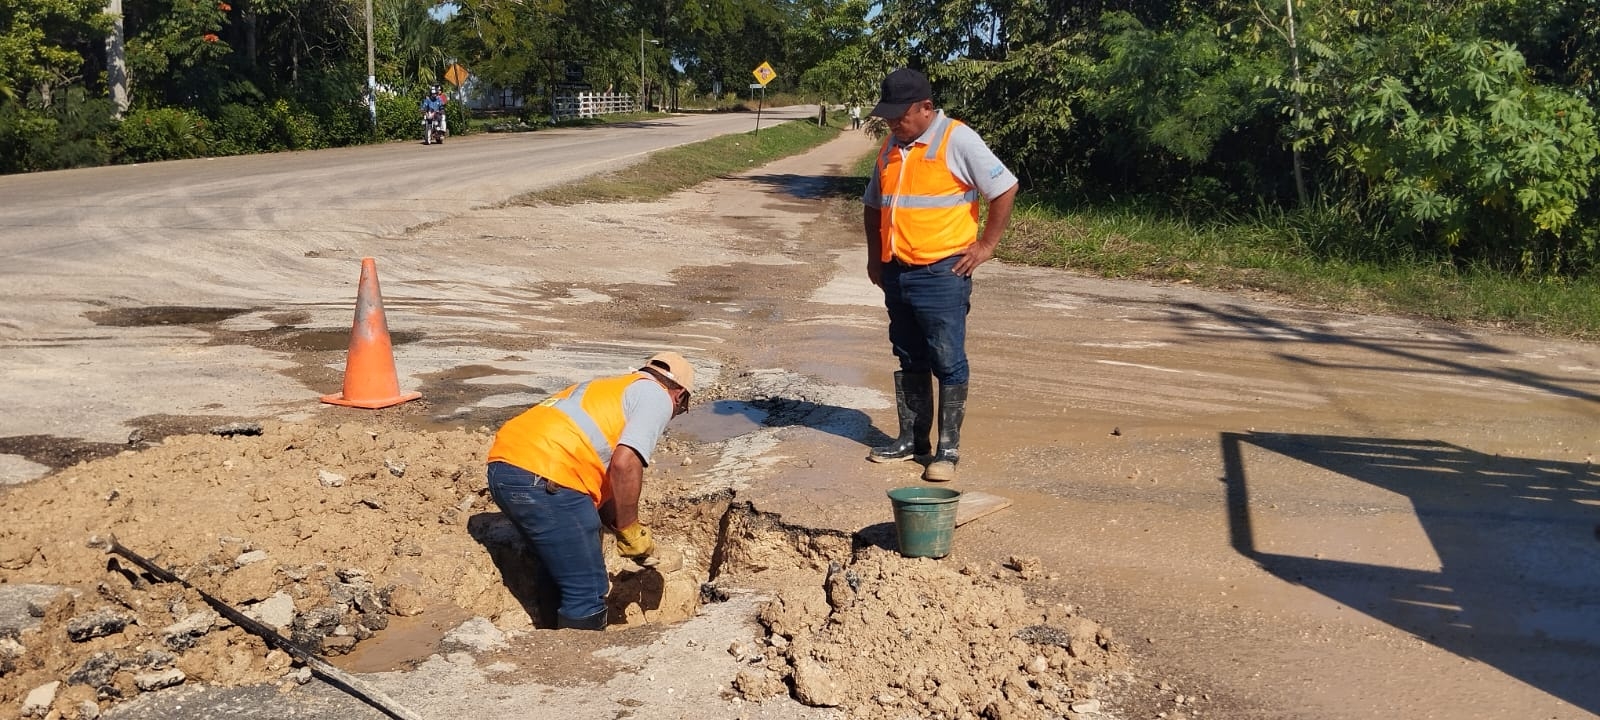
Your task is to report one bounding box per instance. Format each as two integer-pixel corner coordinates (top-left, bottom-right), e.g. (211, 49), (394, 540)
(1291, 3), (1600, 274)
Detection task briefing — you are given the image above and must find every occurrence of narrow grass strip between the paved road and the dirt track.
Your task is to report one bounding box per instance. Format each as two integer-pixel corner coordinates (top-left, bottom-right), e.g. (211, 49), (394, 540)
(512, 114), (850, 205)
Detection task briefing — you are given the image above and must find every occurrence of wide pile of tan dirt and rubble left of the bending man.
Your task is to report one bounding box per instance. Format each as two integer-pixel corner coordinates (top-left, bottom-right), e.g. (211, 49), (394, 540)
(0, 422), (698, 718)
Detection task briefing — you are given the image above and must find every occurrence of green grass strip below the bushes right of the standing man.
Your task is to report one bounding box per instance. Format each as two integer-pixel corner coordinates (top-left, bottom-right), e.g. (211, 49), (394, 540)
(995, 195), (1600, 339)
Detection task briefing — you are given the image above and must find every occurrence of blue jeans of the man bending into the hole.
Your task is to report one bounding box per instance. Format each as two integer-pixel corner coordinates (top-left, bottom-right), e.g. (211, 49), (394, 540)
(490, 462), (610, 619)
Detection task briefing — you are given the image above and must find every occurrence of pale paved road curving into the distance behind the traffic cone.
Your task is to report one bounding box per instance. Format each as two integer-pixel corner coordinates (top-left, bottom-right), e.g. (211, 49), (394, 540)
(0, 106), (814, 264)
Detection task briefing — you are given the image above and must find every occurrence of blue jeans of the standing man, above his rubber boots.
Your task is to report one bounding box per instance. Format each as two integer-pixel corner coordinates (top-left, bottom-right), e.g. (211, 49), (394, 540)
(883, 254), (973, 386)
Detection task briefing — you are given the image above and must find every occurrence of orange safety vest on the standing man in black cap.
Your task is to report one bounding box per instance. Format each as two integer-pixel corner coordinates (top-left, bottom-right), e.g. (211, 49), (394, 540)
(878, 115), (978, 266)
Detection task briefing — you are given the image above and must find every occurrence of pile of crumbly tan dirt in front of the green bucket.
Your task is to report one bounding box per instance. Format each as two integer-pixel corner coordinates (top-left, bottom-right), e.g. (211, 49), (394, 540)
(733, 547), (1128, 720)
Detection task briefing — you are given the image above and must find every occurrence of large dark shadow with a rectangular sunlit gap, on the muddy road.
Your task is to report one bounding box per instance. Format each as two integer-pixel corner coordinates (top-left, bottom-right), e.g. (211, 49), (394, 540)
(1221, 432), (1600, 712)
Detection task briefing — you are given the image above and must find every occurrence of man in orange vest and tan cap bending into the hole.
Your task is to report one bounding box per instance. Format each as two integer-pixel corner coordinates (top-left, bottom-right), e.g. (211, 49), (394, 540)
(488, 352), (694, 630)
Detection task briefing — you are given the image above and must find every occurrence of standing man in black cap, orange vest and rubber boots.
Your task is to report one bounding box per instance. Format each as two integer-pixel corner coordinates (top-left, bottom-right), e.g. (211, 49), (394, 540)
(861, 67), (1018, 482)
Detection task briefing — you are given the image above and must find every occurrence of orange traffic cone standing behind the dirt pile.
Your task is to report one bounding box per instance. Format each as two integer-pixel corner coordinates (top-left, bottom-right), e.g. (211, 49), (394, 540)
(322, 258), (422, 410)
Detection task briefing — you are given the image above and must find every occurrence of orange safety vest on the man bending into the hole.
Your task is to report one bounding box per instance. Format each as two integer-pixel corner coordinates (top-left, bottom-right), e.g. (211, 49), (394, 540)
(488, 373), (653, 507)
